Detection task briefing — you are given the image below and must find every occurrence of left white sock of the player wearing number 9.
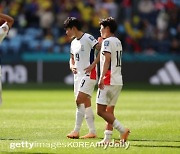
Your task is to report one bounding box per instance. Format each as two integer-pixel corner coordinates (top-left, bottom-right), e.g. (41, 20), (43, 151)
(74, 104), (85, 132)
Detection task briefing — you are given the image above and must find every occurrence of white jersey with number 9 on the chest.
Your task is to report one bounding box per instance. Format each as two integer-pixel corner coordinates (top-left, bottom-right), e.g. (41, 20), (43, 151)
(71, 33), (98, 79)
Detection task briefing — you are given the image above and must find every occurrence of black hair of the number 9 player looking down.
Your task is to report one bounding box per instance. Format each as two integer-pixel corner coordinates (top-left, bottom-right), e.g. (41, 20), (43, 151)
(64, 17), (82, 30)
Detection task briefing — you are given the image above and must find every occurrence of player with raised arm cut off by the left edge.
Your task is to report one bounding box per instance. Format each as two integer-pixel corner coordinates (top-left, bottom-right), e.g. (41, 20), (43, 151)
(0, 13), (14, 104)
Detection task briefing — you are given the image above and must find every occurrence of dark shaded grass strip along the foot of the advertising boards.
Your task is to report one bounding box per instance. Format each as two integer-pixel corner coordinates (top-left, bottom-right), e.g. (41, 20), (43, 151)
(3, 82), (180, 92)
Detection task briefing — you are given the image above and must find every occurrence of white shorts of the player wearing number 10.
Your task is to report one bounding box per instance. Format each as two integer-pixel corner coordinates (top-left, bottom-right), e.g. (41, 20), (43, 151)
(96, 85), (122, 106)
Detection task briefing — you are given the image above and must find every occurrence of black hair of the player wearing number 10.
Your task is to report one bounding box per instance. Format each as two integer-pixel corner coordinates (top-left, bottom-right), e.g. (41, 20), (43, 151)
(99, 17), (117, 33)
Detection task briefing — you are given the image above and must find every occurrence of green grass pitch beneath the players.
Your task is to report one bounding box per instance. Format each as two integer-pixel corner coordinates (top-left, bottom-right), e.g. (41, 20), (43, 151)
(0, 84), (180, 154)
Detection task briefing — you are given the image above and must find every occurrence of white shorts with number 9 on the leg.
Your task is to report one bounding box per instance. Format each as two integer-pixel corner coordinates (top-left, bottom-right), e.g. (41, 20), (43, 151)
(74, 75), (96, 97)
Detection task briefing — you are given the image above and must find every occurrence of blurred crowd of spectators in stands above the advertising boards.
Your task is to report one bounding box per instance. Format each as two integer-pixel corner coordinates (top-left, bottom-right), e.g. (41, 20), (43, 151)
(0, 0), (180, 54)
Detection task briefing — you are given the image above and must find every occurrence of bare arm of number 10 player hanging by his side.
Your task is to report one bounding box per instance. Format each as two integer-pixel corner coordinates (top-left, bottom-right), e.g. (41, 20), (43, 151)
(98, 51), (111, 89)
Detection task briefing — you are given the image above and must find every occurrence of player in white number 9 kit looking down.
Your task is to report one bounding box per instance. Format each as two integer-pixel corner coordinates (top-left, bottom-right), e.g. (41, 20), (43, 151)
(64, 17), (100, 138)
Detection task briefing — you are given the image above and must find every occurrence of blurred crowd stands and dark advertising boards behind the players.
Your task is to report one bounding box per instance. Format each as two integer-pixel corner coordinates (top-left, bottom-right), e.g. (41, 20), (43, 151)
(0, 0), (180, 85)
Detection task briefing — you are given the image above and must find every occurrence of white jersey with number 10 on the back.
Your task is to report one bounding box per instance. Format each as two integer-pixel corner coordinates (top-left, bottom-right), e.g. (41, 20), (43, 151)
(100, 37), (123, 85)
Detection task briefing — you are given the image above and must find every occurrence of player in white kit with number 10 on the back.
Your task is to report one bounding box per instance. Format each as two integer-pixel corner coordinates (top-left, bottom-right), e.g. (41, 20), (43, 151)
(96, 17), (130, 143)
